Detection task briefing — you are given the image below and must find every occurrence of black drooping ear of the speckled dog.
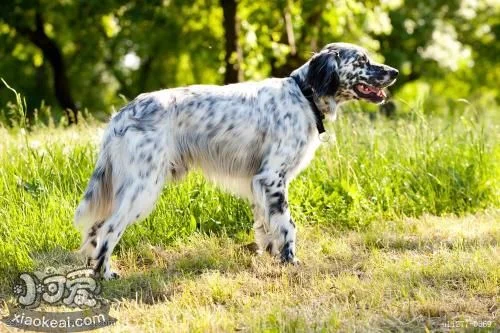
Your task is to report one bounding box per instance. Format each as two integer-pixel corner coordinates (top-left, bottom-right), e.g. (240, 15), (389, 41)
(306, 51), (340, 97)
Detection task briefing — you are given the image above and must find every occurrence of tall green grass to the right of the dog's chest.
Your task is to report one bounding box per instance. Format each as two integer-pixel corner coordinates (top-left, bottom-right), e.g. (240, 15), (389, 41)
(291, 109), (500, 227)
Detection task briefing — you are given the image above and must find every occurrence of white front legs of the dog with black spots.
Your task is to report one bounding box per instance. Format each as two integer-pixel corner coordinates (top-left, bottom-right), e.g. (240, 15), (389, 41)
(252, 171), (297, 263)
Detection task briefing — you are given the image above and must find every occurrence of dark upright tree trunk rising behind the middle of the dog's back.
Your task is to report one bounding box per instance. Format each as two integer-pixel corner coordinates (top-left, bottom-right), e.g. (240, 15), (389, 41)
(220, 0), (243, 84)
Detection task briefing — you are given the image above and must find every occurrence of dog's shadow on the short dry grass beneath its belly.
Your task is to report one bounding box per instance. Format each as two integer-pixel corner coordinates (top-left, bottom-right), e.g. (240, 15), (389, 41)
(99, 240), (262, 304)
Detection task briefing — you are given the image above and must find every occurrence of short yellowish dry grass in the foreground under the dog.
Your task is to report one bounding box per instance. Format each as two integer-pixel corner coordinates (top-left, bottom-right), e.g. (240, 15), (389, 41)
(1, 211), (500, 332)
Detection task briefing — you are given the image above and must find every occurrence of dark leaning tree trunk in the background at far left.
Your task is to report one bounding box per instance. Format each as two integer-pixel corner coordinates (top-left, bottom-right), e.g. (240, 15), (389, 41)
(20, 12), (78, 124)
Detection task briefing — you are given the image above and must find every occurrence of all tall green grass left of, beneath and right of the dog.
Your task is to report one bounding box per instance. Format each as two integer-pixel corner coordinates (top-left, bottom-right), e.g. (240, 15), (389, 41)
(0, 88), (500, 290)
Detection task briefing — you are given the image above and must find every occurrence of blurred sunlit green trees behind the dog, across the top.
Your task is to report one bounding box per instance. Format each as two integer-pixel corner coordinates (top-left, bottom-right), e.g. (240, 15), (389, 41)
(0, 0), (500, 121)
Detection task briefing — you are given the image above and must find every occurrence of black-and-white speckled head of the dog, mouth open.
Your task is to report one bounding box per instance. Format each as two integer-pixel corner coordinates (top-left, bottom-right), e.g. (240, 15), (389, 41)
(305, 43), (398, 104)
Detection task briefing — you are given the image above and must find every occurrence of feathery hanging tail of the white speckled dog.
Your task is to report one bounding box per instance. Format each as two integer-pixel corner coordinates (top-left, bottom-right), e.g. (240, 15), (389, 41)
(74, 149), (113, 239)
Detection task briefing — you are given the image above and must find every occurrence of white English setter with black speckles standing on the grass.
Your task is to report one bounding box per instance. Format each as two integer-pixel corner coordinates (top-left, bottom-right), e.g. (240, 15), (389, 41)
(75, 43), (398, 279)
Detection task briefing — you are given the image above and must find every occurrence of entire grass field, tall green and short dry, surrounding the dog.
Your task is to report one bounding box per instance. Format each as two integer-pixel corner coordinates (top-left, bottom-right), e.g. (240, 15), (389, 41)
(0, 94), (500, 332)
